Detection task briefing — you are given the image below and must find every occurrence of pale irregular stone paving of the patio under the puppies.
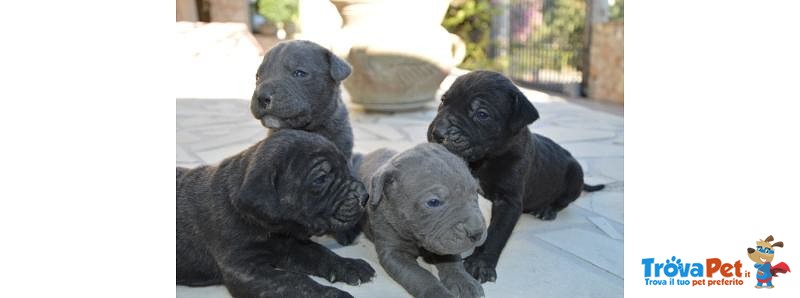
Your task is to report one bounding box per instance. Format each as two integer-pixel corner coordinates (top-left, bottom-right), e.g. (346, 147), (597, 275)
(176, 74), (624, 298)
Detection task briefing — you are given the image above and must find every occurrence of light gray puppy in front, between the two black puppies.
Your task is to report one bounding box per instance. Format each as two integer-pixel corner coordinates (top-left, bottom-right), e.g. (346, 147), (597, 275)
(355, 143), (486, 298)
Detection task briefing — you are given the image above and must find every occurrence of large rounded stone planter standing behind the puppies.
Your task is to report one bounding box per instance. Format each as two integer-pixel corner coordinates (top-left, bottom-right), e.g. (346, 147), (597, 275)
(331, 0), (466, 111)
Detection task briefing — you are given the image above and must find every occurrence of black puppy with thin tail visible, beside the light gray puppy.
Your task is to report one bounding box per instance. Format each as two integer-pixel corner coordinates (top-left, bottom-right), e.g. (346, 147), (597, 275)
(428, 71), (603, 282)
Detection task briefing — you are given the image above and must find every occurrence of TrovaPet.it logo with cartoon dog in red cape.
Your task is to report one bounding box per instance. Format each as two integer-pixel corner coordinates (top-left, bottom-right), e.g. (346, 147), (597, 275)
(642, 235), (791, 289)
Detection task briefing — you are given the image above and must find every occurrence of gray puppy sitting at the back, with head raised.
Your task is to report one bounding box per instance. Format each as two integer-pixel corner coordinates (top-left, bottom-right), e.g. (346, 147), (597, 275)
(250, 40), (353, 158)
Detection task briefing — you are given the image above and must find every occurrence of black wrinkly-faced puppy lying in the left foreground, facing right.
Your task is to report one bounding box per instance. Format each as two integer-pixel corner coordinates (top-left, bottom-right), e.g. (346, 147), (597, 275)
(176, 130), (375, 297)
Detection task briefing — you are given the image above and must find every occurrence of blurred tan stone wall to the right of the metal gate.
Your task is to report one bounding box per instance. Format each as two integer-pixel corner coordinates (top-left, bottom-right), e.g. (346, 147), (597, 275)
(587, 21), (625, 103)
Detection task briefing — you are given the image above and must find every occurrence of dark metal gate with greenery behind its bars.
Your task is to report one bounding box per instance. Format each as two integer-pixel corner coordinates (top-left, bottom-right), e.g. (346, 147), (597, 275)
(508, 0), (586, 96)
